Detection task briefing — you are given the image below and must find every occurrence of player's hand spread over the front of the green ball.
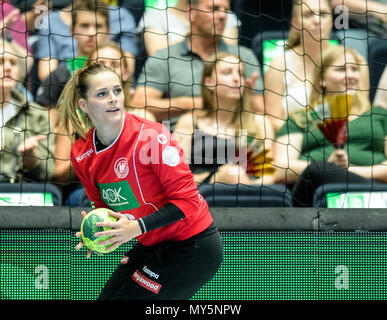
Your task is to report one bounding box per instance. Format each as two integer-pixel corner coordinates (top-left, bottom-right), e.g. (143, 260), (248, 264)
(94, 211), (142, 254)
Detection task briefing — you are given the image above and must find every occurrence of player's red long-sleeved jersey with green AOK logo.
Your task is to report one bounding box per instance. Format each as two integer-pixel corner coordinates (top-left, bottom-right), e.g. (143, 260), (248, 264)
(71, 113), (213, 246)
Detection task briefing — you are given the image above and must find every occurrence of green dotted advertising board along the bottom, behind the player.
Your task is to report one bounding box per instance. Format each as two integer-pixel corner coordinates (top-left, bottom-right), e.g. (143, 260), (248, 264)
(0, 229), (387, 300)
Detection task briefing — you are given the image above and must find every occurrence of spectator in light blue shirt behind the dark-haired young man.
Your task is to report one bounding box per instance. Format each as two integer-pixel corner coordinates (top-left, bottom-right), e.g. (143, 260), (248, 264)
(34, 0), (138, 81)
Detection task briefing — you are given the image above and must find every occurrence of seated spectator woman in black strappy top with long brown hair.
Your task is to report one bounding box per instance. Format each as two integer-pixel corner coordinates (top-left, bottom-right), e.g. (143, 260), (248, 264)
(173, 52), (274, 184)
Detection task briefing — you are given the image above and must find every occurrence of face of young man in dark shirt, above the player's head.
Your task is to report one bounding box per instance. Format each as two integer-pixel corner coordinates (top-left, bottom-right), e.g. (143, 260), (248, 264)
(73, 11), (109, 55)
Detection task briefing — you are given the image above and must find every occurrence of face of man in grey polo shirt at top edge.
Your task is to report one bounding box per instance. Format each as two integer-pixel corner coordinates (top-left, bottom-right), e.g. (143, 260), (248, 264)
(190, 0), (230, 36)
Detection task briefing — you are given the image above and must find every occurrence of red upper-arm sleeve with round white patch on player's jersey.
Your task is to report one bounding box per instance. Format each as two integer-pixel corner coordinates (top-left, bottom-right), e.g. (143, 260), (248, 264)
(140, 124), (199, 217)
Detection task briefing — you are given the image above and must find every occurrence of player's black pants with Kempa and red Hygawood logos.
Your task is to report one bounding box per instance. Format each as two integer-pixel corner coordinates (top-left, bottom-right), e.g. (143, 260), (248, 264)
(98, 225), (223, 300)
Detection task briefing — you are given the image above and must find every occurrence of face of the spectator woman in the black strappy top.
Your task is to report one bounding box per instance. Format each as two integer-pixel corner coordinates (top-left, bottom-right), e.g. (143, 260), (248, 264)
(205, 56), (245, 104)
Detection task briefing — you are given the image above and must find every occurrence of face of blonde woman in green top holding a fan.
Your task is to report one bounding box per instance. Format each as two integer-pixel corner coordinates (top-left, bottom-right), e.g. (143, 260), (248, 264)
(322, 53), (360, 94)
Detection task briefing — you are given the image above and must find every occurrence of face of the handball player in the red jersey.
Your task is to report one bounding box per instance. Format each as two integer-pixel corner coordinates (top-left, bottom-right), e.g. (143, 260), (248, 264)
(79, 71), (124, 127)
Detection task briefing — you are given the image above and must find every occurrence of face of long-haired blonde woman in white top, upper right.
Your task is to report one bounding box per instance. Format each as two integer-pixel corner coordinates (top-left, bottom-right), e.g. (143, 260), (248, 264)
(292, 0), (333, 42)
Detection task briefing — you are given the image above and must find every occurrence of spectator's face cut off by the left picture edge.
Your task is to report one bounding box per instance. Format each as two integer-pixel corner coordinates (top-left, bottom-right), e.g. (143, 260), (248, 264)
(0, 42), (19, 93)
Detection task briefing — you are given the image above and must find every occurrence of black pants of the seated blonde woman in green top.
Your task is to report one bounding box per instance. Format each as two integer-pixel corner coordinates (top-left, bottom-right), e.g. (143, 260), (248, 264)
(293, 161), (371, 207)
